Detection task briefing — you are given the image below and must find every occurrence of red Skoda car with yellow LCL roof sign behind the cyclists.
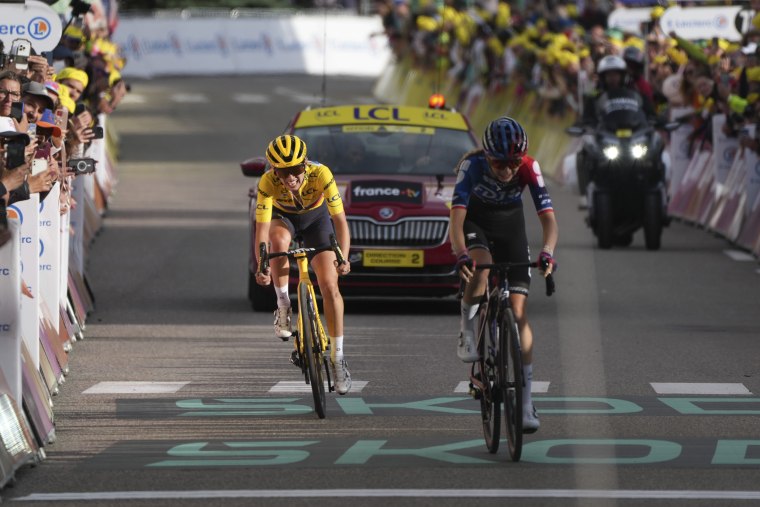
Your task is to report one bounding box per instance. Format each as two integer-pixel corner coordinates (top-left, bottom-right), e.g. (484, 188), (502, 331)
(241, 105), (477, 311)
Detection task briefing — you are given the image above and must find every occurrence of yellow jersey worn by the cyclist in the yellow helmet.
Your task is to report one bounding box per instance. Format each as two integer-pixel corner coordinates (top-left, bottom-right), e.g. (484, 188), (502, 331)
(256, 162), (343, 222)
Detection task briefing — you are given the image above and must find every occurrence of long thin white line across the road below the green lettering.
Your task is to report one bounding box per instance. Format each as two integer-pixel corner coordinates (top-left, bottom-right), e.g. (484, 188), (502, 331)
(14, 489), (760, 502)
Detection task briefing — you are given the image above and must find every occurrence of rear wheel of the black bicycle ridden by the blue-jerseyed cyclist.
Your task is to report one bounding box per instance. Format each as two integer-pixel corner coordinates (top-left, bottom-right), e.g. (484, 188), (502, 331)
(475, 300), (502, 454)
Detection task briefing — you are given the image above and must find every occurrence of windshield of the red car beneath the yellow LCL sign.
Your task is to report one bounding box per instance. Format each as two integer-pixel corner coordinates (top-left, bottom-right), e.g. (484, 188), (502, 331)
(294, 125), (476, 175)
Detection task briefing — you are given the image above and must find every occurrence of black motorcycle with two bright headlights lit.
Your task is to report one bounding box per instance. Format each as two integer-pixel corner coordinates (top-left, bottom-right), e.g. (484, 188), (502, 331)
(566, 110), (679, 250)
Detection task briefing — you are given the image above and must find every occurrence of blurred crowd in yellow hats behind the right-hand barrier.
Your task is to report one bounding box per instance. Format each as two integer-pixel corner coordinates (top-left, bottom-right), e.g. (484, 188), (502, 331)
(377, 0), (760, 163)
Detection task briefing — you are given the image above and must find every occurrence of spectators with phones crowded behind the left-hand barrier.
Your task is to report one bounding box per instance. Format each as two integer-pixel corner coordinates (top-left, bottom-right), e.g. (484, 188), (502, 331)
(0, 1), (127, 250)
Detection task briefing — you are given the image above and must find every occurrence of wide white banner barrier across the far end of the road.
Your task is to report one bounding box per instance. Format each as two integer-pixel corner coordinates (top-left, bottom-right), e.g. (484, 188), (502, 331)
(113, 14), (391, 77)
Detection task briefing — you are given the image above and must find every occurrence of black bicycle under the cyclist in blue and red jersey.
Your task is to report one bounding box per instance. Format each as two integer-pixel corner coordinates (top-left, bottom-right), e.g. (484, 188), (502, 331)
(460, 262), (554, 461)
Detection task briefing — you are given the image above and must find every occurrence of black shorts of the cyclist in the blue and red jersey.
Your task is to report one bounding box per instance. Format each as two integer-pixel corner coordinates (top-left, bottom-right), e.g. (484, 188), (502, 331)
(464, 206), (530, 296)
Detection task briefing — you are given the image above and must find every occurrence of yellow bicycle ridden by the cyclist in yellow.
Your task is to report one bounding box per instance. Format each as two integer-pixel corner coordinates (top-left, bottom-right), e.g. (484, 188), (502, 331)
(259, 235), (346, 419)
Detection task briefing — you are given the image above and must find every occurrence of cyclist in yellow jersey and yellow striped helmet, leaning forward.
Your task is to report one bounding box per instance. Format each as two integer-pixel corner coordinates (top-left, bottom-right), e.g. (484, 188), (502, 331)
(254, 135), (351, 394)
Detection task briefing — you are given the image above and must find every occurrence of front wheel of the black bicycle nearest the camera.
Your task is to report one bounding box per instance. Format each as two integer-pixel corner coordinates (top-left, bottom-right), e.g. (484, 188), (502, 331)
(499, 308), (523, 461)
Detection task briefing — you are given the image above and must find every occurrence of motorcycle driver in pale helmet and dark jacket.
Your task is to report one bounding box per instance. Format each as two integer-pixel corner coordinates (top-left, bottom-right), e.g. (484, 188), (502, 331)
(575, 55), (655, 203)
